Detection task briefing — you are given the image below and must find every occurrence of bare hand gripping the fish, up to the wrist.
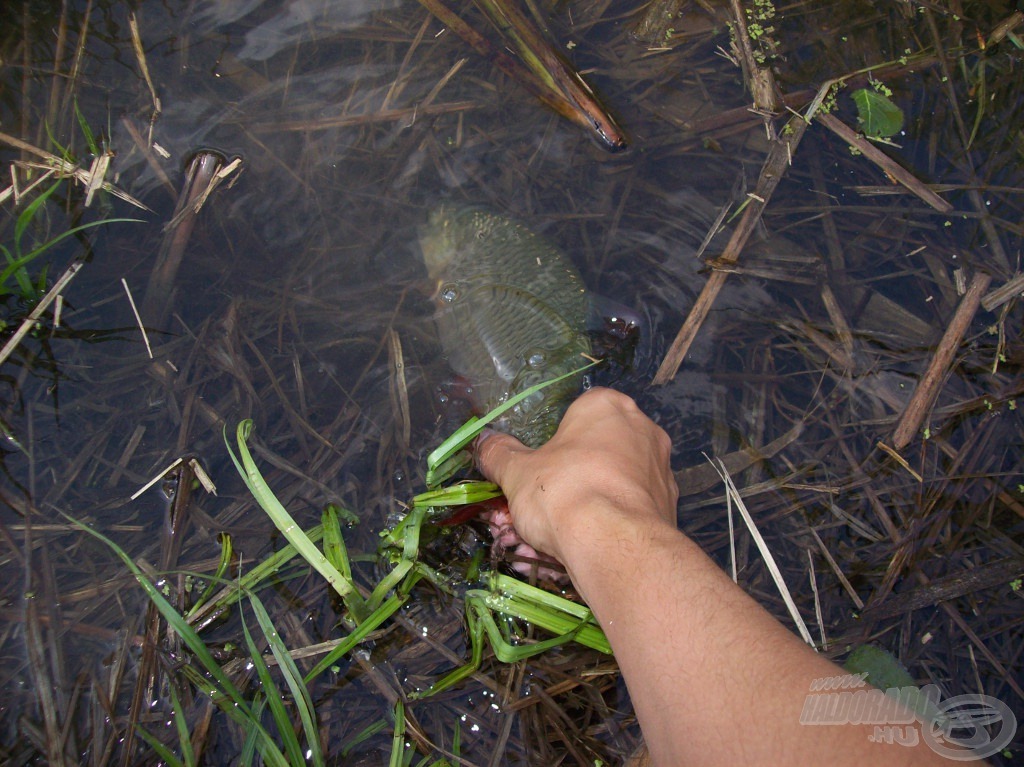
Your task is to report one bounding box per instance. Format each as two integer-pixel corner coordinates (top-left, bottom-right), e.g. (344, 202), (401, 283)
(476, 388), (679, 574)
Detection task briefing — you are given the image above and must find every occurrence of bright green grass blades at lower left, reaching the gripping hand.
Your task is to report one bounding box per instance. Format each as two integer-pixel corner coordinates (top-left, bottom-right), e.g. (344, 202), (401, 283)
(72, 382), (611, 765)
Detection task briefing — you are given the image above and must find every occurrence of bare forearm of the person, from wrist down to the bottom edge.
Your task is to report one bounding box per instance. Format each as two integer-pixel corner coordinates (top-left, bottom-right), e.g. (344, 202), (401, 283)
(566, 512), (941, 765)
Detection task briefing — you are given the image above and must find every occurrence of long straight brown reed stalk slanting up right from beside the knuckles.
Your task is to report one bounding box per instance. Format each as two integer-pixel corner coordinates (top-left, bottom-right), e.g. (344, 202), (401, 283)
(651, 115), (807, 384)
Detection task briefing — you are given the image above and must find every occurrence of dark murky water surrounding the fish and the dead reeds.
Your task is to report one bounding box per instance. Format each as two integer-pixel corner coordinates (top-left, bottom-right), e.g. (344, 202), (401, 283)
(0, 0), (1022, 764)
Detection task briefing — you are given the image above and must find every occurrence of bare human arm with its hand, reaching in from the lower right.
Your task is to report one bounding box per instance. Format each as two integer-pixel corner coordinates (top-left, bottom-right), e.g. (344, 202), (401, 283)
(477, 389), (945, 765)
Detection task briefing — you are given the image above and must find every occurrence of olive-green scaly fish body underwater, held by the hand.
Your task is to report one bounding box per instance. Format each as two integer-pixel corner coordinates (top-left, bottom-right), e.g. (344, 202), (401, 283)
(420, 205), (591, 448)
